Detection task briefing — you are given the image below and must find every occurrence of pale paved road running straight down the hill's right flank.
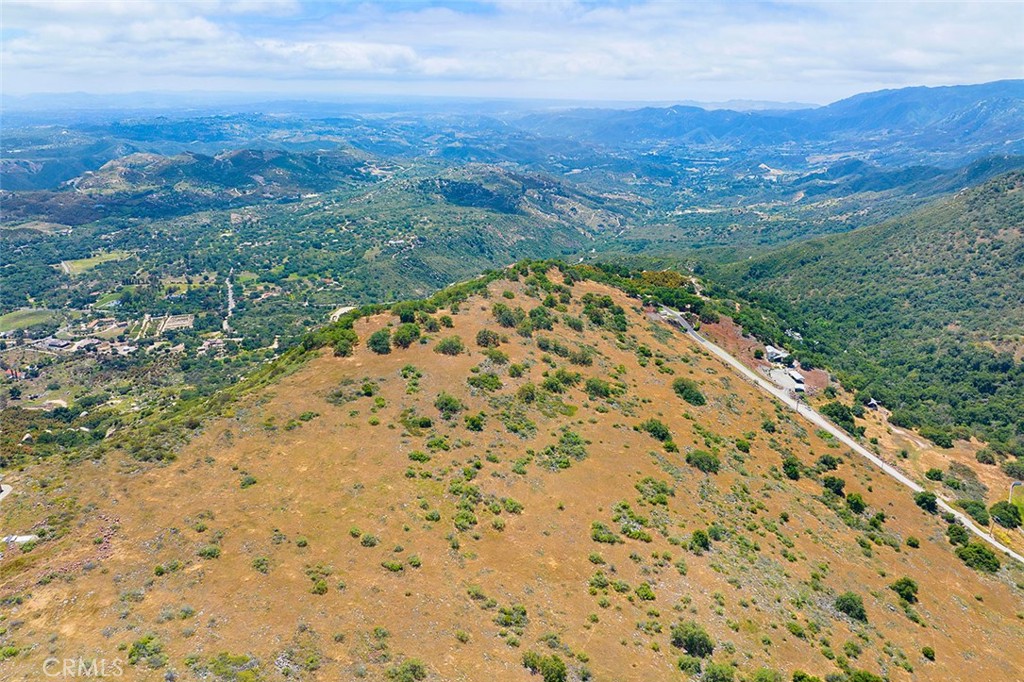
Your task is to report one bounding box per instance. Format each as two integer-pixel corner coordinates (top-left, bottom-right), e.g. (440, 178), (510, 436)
(663, 308), (1024, 563)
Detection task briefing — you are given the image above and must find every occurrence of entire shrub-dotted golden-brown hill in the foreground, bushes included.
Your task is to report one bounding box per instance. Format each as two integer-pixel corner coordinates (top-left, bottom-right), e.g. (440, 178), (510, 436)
(0, 264), (1024, 680)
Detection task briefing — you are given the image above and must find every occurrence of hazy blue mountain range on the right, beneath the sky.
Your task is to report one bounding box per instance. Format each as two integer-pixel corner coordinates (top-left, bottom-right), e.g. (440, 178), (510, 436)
(516, 80), (1024, 165)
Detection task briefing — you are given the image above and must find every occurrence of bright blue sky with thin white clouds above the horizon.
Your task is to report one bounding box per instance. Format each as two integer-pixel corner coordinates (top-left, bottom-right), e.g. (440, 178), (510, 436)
(0, 0), (1024, 103)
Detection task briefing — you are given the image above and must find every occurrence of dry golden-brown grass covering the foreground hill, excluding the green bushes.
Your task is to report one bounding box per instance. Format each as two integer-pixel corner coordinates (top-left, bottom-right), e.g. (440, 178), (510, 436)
(0, 274), (1024, 680)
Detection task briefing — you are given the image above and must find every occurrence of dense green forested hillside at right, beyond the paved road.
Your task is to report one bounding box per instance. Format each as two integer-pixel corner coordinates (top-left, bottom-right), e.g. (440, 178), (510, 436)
(717, 171), (1024, 454)
